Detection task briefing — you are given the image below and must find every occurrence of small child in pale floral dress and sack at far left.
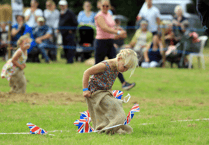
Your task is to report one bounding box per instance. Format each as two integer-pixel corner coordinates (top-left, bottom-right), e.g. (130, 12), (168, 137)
(1, 34), (31, 93)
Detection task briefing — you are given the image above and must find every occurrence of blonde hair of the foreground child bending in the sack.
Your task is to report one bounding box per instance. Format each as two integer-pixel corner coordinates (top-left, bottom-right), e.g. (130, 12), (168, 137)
(116, 49), (138, 77)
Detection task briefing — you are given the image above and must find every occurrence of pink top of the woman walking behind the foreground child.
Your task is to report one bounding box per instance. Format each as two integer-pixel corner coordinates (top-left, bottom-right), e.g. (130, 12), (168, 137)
(94, 11), (115, 39)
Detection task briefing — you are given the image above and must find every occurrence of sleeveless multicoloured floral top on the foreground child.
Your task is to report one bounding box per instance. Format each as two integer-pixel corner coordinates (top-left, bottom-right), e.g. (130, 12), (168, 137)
(88, 61), (119, 93)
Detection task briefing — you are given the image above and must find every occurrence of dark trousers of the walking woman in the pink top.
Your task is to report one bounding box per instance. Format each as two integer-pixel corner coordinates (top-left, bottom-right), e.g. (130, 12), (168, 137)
(94, 39), (125, 83)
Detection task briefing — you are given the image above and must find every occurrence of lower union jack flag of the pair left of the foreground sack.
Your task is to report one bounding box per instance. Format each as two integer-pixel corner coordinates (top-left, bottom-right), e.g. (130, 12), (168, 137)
(74, 118), (94, 133)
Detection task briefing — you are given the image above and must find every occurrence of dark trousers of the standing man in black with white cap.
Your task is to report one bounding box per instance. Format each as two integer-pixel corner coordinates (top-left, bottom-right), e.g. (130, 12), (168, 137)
(62, 33), (76, 63)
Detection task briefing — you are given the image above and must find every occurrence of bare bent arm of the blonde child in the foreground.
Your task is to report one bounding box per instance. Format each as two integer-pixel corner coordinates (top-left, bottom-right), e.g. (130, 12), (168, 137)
(83, 63), (106, 97)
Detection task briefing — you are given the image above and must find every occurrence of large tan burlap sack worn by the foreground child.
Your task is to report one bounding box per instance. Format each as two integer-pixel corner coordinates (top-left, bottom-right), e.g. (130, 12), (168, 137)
(86, 90), (133, 134)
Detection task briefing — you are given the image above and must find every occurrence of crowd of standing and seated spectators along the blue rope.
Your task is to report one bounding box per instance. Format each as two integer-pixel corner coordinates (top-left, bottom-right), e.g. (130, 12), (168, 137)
(0, 0), (200, 68)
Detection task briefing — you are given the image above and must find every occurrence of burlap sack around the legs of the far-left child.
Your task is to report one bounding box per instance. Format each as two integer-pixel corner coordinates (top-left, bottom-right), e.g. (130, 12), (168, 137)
(9, 70), (27, 93)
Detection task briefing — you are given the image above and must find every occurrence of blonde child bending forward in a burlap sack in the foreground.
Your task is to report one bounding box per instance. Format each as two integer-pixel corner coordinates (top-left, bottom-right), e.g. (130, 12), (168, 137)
(83, 49), (138, 134)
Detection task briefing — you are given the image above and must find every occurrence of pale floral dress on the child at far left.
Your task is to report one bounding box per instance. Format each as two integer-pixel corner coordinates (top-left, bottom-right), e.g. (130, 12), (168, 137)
(1, 48), (28, 81)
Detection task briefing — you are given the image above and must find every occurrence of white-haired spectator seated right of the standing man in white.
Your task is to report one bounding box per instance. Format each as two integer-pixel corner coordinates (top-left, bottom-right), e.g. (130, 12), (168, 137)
(173, 5), (187, 41)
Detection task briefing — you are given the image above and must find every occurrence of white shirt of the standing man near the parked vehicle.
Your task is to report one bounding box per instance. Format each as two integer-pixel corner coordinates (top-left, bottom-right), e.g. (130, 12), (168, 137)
(138, 6), (160, 32)
